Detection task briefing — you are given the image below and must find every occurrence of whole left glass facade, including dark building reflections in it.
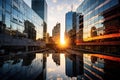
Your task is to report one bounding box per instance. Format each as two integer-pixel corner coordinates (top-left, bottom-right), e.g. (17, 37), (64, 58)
(0, 0), (43, 40)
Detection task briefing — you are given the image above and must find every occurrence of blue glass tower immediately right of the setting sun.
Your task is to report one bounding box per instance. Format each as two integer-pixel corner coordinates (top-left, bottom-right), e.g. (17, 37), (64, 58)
(65, 11), (76, 45)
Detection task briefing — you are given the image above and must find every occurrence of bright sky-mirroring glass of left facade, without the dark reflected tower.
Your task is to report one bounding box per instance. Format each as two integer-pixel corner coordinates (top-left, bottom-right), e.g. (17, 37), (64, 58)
(0, 0), (43, 39)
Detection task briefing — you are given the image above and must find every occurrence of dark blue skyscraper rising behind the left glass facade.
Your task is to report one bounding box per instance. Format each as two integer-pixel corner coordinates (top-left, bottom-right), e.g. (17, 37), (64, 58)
(32, 0), (47, 41)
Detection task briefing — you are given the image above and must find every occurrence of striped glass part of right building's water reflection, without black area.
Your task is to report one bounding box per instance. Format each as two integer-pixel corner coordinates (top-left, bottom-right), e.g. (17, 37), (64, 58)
(84, 55), (104, 80)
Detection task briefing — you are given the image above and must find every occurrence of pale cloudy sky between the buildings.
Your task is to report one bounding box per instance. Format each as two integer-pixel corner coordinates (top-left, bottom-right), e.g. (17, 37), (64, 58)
(24, 0), (83, 38)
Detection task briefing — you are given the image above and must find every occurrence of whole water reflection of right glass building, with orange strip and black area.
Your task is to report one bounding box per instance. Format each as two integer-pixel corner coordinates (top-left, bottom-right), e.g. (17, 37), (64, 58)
(83, 54), (120, 80)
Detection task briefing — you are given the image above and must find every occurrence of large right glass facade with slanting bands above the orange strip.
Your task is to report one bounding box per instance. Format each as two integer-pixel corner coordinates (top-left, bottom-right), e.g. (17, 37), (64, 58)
(77, 0), (120, 40)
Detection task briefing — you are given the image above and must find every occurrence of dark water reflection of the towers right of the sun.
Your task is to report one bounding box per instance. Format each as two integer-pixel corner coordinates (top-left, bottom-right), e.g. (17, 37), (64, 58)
(65, 54), (83, 79)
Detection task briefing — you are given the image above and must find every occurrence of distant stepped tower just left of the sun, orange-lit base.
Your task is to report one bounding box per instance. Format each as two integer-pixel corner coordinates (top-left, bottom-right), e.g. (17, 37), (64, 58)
(52, 23), (60, 44)
